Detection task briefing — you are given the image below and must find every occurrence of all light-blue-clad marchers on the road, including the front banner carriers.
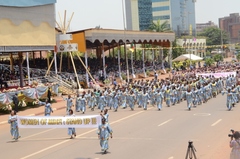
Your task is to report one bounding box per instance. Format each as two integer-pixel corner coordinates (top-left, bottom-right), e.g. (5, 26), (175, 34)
(9, 60), (240, 153)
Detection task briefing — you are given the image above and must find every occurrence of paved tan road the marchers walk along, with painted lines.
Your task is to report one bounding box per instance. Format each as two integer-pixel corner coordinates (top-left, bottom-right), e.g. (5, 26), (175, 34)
(0, 95), (240, 159)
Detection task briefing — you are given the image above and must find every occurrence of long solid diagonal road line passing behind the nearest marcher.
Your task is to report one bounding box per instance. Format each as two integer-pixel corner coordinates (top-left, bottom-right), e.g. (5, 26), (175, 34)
(21, 111), (146, 159)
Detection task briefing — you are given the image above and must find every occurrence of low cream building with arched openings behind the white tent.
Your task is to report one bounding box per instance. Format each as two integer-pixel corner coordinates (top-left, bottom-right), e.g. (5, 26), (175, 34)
(177, 38), (206, 57)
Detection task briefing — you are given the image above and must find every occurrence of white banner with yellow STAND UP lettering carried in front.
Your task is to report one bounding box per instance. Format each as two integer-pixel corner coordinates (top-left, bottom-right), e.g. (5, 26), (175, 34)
(18, 115), (101, 128)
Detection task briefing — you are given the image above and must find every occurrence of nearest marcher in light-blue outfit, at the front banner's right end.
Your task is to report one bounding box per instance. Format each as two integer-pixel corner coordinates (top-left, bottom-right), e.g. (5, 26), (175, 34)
(98, 118), (113, 154)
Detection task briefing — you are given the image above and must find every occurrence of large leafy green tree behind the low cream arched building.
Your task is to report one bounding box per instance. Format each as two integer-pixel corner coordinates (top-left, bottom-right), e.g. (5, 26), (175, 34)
(198, 27), (229, 50)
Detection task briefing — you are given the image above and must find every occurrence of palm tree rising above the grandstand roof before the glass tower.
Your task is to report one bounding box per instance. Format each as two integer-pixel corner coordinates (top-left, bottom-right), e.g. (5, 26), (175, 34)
(149, 20), (171, 32)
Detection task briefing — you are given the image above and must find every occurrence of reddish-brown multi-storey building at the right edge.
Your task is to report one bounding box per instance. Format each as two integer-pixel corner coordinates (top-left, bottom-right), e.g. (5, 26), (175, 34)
(219, 13), (240, 44)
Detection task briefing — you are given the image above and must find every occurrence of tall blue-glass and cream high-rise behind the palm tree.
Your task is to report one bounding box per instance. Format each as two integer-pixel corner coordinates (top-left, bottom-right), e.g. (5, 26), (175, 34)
(125, 0), (196, 36)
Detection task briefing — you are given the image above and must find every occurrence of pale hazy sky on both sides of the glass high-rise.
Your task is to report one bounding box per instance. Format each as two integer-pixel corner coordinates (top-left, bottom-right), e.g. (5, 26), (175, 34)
(56, 0), (240, 31)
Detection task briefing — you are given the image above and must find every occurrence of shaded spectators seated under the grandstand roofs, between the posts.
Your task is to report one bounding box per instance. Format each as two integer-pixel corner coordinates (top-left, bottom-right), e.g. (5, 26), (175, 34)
(1, 57), (168, 81)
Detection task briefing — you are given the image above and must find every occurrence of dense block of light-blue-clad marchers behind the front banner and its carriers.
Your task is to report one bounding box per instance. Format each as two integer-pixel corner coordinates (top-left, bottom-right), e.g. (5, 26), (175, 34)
(60, 72), (240, 113)
